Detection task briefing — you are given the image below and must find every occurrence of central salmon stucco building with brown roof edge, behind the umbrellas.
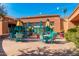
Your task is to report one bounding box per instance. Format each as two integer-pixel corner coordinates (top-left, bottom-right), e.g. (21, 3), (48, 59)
(20, 15), (63, 32)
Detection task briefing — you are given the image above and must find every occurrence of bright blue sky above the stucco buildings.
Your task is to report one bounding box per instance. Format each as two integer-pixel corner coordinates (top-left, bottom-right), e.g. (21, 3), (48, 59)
(5, 3), (78, 18)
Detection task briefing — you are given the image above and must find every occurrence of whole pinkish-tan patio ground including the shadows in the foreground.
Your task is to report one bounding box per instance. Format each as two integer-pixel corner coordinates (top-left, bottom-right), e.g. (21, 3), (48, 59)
(2, 39), (79, 56)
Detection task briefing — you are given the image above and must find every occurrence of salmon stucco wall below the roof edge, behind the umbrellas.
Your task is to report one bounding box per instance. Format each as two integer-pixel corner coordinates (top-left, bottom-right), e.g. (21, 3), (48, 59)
(21, 17), (63, 32)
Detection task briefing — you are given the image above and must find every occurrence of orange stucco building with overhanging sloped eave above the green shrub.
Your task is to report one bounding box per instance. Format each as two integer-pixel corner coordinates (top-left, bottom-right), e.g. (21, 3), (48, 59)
(64, 5), (79, 32)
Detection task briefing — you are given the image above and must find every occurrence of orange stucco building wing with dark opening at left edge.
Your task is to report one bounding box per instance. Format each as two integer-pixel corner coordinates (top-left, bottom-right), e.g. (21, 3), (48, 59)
(0, 16), (16, 35)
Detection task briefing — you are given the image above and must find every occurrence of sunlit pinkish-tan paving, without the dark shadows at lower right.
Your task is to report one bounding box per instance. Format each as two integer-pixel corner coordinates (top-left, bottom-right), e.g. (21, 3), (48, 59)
(2, 39), (75, 56)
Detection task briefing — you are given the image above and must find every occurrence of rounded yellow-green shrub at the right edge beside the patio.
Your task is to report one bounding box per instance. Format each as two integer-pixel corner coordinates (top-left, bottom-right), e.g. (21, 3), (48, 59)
(65, 27), (79, 47)
